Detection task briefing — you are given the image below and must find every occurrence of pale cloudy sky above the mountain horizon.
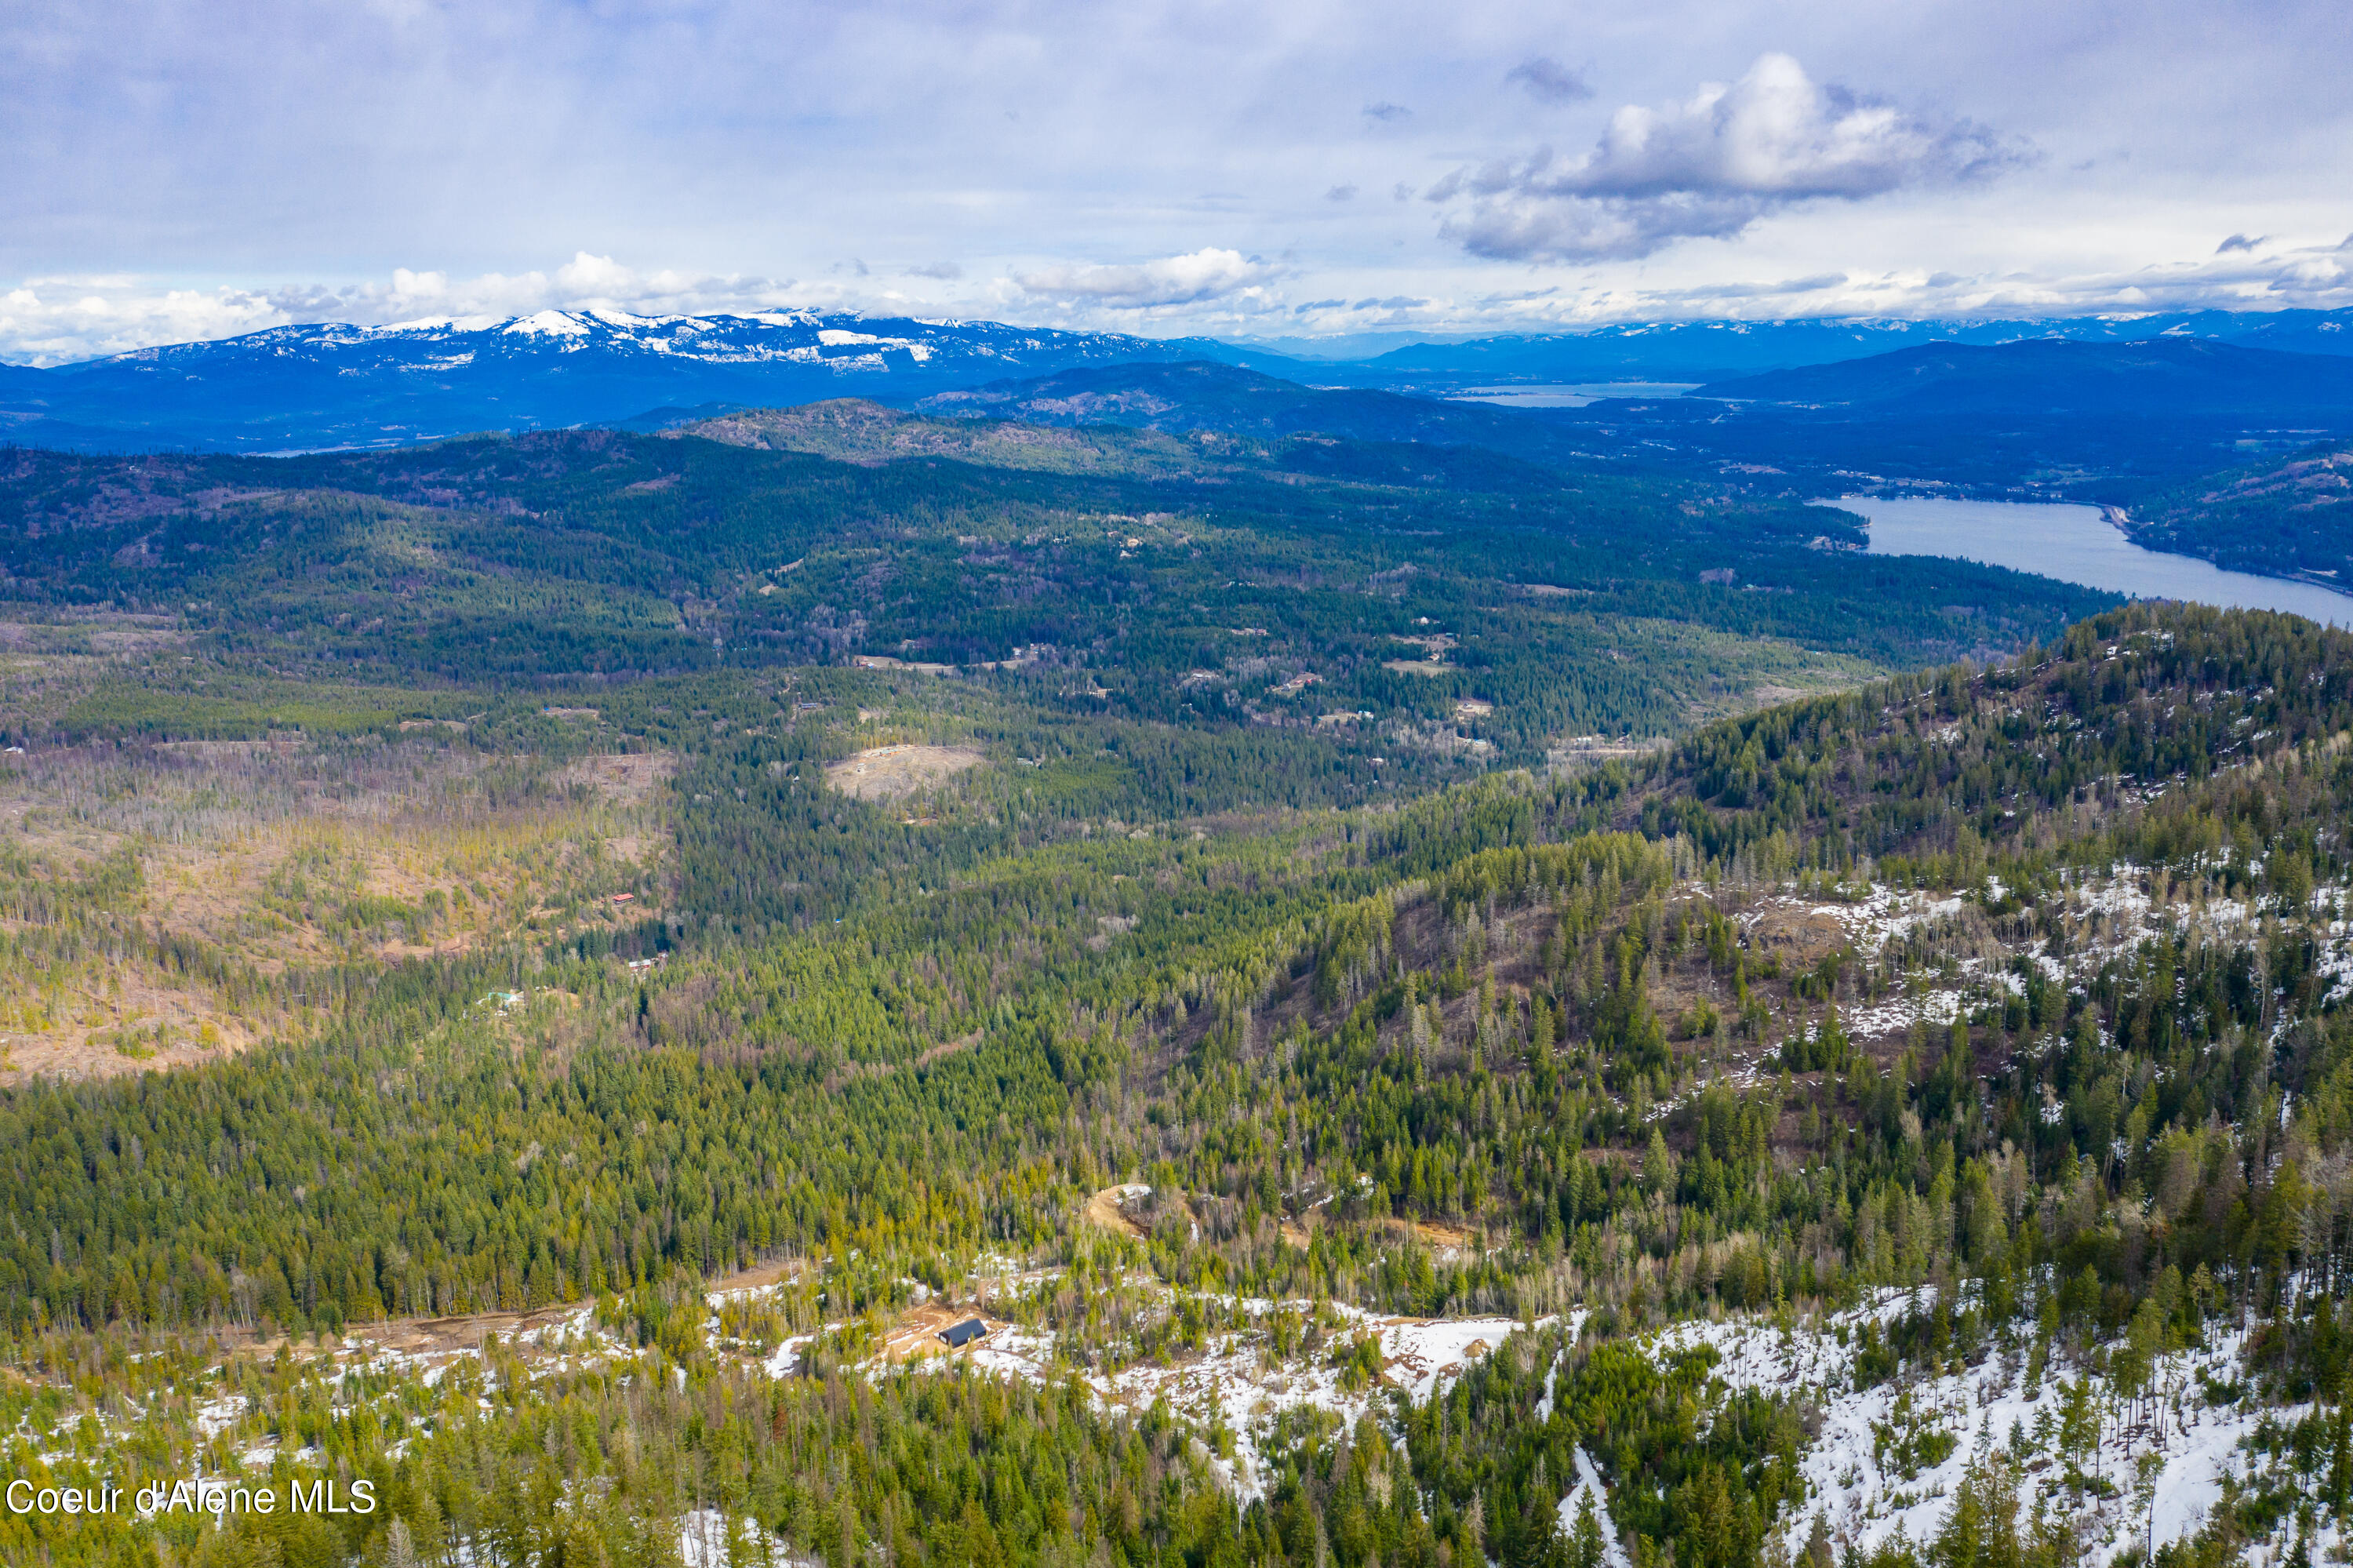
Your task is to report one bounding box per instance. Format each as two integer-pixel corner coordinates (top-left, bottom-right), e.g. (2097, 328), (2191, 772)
(0, 0), (2353, 365)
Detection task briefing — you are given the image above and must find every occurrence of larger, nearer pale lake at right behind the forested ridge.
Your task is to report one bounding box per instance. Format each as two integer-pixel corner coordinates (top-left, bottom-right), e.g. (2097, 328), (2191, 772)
(1814, 497), (2353, 626)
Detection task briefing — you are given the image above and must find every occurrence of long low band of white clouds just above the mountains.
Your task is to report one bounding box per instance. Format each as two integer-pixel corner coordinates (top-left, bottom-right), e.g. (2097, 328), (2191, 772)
(13, 231), (2353, 365)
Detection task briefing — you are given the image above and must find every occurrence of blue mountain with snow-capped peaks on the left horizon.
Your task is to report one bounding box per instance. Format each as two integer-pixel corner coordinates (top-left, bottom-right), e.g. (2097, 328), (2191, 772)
(0, 311), (1242, 452)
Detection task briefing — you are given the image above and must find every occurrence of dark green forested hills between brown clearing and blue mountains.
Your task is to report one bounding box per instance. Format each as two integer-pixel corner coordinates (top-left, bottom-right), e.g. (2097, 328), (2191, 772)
(0, 405), (2106, 739)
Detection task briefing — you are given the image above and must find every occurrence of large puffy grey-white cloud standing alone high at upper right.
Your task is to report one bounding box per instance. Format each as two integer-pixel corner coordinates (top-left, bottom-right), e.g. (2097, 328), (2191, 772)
(1426, 54), (2021, 261)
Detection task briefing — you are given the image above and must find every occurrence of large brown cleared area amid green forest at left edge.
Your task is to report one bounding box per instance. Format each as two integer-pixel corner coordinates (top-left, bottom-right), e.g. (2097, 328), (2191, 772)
(0, 734), (673, 1083)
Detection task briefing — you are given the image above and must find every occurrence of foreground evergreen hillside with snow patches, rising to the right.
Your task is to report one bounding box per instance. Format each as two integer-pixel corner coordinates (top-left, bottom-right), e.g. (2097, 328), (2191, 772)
(0, 607), (2353, 1568)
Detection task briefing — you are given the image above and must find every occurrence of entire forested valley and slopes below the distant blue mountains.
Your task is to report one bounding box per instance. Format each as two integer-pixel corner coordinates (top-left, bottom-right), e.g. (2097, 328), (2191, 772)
(0, 393), (2353, 1568)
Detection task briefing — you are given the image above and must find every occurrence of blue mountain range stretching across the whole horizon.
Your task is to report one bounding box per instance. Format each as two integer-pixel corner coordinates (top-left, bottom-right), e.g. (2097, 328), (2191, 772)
(0, 311), (2353, 452)
